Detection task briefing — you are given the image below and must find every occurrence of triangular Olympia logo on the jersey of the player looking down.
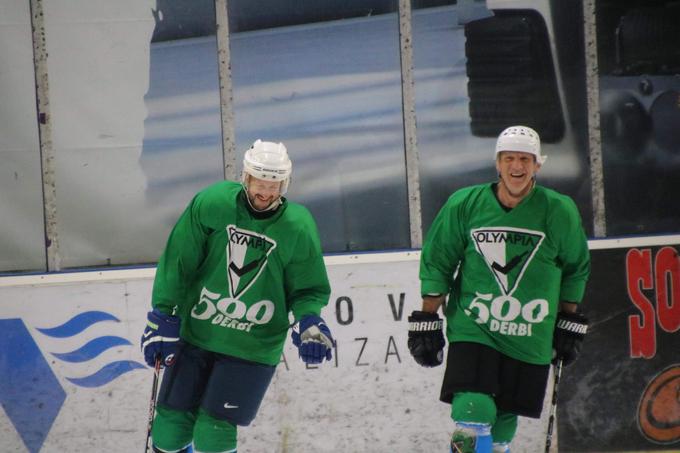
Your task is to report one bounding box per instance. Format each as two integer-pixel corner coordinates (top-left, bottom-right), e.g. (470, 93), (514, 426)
(227, 225), (276, 298)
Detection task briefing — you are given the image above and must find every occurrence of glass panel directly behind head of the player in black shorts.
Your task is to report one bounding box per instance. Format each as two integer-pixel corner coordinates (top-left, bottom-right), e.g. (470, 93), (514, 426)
(413, 0), (592, 234)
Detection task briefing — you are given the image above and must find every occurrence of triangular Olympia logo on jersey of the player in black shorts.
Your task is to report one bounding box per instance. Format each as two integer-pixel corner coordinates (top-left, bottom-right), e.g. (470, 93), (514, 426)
(470, 227), (545, 295)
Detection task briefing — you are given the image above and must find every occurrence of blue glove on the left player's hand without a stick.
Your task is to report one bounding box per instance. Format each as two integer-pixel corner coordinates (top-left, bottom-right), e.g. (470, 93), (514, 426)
(291, 315), (335, 364)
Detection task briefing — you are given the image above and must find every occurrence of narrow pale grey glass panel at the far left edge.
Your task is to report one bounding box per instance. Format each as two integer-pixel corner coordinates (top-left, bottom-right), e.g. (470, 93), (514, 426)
(0, 2), (46, 272)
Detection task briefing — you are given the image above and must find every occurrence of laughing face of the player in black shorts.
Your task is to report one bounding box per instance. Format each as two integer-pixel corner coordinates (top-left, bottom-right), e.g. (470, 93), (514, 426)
(496, 151), (541, 207)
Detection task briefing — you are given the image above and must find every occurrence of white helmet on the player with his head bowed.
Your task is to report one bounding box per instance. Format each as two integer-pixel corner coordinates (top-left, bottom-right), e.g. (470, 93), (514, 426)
(243, 139), (293, 195)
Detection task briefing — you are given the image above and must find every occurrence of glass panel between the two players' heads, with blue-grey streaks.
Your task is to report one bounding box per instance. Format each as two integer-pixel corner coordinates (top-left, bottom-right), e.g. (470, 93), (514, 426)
(228, 0), (410, 252)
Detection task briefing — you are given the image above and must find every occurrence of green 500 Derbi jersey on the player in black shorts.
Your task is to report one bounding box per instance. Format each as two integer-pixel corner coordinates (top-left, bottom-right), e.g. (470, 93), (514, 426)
(420, 184), (590, 365)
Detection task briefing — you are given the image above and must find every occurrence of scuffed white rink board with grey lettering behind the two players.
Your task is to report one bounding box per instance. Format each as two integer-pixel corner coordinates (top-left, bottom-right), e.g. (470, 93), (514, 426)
(0, 253), (549, 453)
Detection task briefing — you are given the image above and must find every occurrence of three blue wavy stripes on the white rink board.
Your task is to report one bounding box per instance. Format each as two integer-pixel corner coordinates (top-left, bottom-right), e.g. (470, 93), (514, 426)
(37, 311), (146, 387)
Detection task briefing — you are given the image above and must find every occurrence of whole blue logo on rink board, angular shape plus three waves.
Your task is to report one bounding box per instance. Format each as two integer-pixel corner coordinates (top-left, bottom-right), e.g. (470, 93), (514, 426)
(0, 311), (146, 453)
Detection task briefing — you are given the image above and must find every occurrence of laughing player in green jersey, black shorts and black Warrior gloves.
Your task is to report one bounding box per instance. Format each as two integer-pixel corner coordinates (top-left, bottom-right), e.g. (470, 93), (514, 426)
(408, 126), (590, 453)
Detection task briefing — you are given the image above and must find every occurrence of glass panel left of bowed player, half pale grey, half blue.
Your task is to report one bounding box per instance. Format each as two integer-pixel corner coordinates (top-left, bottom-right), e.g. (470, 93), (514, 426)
(45, 0), (222, 268)
